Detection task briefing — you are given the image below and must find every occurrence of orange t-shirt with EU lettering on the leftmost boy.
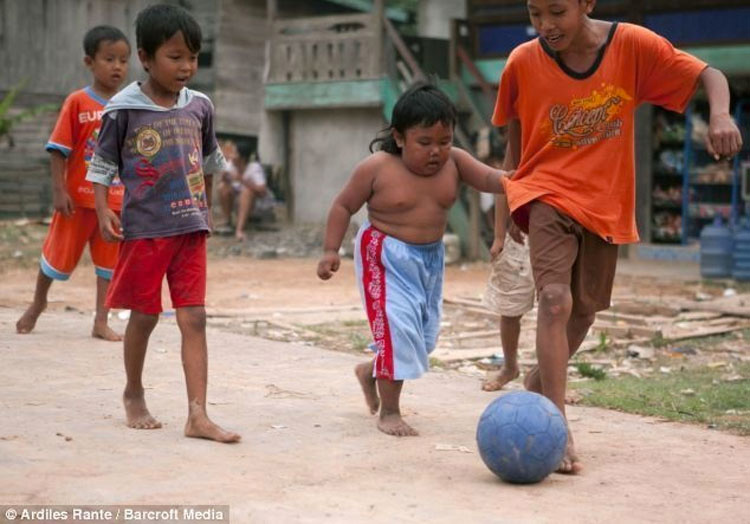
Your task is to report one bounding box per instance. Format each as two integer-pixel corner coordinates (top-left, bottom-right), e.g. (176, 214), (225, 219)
(44, 87), (124, 211)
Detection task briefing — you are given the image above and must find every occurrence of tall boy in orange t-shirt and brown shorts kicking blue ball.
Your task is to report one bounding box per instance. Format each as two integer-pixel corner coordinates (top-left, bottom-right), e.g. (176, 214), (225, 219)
(493, 0), (742, 473)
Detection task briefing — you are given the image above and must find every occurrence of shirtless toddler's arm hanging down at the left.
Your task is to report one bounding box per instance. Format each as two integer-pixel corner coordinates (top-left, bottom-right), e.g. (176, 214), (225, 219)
(318, 153), (378, 280)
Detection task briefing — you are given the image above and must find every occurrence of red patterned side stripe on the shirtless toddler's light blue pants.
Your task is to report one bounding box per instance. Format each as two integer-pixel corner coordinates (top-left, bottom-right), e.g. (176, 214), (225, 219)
(360, 226), (393, 380)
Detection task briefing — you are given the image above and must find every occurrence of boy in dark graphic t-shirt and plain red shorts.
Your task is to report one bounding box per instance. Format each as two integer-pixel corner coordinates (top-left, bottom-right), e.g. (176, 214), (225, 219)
(87, 5), (240, 442)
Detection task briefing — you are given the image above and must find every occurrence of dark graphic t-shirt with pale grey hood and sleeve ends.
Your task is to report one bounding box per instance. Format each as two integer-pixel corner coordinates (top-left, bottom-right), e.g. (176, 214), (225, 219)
(88, 85), (222, 239)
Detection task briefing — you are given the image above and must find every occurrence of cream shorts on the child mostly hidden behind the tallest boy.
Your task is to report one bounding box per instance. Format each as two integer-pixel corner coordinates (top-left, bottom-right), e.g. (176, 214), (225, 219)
(482, 235), (535, 317)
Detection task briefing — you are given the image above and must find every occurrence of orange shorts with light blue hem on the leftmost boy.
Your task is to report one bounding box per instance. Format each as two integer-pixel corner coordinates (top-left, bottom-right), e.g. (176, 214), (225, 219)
(40, 207), (120, 280)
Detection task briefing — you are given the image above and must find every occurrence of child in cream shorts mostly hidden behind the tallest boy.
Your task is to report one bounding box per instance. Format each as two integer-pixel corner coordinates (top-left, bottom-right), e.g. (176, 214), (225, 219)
(482, 147), (535, 391)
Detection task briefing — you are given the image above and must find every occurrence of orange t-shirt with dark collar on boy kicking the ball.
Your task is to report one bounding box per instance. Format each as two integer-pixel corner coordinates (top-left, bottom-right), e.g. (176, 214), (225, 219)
(492, 23), (706, 244)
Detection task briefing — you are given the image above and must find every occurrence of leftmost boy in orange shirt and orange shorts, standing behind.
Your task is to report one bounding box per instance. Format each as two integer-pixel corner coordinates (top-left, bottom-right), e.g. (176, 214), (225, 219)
(16, 26), (130, 341)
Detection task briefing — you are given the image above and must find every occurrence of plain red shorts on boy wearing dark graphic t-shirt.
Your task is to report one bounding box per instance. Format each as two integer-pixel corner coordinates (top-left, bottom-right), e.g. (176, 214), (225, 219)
(107, 231), (206, 315)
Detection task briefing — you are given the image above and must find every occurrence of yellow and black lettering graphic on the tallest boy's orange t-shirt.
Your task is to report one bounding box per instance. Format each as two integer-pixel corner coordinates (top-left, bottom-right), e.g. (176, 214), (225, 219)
(549, 84), (633, 149)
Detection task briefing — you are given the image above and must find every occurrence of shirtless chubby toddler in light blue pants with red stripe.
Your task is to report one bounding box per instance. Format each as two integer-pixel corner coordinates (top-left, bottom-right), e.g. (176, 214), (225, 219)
(317, 84), (516, 436)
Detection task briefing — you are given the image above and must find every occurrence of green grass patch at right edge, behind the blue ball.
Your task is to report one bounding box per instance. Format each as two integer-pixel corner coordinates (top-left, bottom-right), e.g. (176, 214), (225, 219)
(571, 363), (750, 435)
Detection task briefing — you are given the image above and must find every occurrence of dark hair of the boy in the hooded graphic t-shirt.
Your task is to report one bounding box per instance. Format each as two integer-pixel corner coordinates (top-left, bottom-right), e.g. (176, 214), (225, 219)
(135, 4), (203, 57)
